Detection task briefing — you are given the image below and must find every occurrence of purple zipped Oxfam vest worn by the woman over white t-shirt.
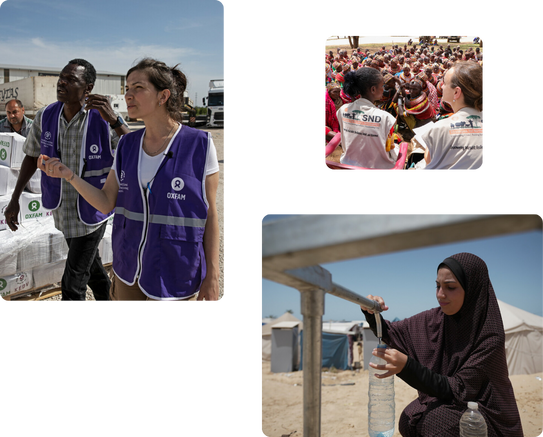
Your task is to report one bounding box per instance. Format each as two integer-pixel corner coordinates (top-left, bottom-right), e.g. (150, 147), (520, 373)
(112, 126), (209, 300)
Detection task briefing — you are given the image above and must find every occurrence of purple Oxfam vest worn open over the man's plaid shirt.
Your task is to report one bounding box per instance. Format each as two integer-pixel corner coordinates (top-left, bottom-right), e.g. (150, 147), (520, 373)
(40, 102), (113, 225)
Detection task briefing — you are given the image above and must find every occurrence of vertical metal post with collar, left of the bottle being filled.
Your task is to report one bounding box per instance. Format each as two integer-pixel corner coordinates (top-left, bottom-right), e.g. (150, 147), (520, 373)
(300, 289), (326, 437)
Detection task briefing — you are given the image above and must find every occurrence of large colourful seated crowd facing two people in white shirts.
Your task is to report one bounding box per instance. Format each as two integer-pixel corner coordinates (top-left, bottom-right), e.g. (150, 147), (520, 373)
(323, 44), (481, 144)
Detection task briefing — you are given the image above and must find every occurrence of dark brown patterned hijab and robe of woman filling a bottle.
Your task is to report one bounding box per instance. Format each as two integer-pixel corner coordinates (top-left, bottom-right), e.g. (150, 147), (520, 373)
(386, 253), (523, 437)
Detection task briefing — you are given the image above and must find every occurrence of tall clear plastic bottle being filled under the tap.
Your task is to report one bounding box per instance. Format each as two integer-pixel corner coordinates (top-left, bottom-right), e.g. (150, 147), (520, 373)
(368, 344), (395, 437)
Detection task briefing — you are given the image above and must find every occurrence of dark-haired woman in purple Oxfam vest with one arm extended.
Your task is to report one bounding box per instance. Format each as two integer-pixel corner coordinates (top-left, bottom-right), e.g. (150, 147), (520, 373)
(38, 58), (219, 302)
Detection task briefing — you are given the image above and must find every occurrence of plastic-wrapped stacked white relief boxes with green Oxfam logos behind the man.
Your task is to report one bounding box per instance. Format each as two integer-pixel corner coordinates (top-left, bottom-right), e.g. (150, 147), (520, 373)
(0, 133), (112, 297)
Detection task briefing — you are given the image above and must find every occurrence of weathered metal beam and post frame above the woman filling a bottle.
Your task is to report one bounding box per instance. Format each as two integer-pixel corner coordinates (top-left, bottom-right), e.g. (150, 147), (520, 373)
(260, 213), (543, 437)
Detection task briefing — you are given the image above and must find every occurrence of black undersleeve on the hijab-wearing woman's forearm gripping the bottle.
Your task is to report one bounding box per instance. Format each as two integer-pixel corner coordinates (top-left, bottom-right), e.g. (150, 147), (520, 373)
(398, 357), (453, 401)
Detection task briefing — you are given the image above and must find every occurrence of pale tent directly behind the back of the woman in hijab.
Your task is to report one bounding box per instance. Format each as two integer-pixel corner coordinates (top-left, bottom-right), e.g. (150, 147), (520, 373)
(498, 300), (543, 375)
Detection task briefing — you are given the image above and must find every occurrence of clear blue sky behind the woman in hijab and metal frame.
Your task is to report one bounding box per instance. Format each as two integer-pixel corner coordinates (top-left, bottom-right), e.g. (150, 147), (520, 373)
(260, 213), (543, 321)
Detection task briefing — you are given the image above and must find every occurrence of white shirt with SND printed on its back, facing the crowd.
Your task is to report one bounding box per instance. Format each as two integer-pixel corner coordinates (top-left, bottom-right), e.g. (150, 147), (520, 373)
(337, 99), (398, 168)
